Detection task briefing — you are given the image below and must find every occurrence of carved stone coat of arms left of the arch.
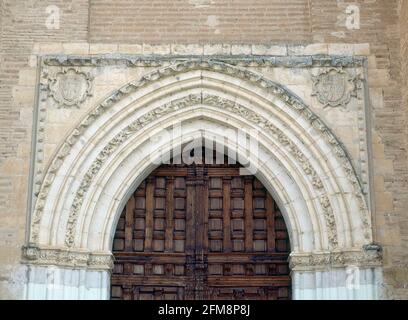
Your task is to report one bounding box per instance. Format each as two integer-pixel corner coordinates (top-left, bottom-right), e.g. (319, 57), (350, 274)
(48, 68), (93, 108)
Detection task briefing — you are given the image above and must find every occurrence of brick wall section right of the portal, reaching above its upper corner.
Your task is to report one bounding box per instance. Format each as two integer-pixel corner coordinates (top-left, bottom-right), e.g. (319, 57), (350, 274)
(311, 0), (408, 298)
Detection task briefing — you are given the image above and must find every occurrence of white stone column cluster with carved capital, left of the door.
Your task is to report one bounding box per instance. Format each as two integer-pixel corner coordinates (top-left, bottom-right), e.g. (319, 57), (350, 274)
(23, 244), (113, 300)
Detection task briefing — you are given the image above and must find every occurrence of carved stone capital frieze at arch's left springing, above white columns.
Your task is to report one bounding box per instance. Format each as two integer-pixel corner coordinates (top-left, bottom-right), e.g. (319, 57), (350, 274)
(23, 244), (113, 270)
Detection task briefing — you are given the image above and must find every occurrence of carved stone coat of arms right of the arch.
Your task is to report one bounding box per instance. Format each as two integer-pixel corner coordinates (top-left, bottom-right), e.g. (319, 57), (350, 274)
(312, 68), (357, 108)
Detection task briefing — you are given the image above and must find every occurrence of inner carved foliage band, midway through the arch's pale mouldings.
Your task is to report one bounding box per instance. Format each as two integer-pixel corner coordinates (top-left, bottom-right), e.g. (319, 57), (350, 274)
(65, 94), (338, 248)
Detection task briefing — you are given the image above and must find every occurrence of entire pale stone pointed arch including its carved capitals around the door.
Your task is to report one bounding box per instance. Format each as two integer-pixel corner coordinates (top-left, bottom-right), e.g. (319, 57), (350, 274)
(25, 61), (379, 298)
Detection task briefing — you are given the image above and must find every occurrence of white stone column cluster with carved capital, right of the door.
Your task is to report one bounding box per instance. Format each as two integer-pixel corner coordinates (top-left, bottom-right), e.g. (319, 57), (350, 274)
(290, 245), (383, 300)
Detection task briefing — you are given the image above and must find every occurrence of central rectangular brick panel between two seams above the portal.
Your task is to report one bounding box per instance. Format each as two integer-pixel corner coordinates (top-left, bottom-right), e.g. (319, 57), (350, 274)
(90, 0), (310, 43)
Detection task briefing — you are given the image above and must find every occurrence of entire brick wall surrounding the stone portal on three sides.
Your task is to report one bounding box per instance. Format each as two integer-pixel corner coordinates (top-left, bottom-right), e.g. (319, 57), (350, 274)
(0, 0), (408, 299)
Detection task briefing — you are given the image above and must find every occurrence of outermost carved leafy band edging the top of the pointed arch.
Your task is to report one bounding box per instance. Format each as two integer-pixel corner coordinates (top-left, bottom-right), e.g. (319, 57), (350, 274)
(31, 58), (371, 242)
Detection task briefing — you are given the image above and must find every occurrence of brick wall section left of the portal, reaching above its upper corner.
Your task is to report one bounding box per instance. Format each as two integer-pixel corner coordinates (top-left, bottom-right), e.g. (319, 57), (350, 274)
(0, 0), (88, 299)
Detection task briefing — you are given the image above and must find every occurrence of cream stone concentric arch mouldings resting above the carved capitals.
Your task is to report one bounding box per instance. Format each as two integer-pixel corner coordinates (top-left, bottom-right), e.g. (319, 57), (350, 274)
(31, 61), (371, 255)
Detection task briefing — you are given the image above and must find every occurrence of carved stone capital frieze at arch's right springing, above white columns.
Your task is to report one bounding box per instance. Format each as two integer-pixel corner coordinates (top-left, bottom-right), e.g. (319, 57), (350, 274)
(289, 245), (382, 271)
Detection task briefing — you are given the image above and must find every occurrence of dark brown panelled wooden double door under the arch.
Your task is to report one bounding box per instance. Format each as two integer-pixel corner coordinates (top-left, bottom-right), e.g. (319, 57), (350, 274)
(111, 165), (291, 300)
